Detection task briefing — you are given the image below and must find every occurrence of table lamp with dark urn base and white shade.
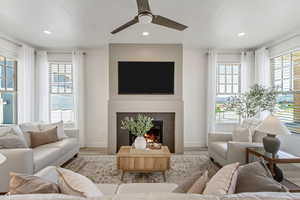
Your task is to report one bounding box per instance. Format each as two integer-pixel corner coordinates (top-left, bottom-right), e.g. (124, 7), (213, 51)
(255, 114), (290, 157)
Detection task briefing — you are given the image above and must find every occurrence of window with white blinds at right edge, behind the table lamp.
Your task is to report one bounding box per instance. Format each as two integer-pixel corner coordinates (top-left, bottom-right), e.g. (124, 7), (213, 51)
(271, 51), (300, 133)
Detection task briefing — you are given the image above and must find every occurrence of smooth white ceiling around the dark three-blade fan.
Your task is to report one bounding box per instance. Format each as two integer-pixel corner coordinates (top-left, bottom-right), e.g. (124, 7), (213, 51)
(0, 0), (300, 48)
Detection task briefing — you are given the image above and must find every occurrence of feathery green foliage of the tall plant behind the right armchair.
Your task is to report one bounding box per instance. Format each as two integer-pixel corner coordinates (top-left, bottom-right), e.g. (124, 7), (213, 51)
(224, 84), (277, 119)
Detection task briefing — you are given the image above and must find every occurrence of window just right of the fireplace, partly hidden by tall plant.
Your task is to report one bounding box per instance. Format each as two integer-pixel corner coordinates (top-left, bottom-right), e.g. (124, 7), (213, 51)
(216, 63), (241, 123)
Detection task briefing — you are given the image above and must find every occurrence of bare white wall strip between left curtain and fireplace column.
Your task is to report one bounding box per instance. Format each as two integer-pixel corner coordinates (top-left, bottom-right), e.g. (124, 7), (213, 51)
(84, 46), (109, 147)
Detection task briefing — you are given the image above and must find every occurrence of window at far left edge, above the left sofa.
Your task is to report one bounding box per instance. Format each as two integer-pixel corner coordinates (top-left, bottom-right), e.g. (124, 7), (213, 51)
(0, 56), (17, 124)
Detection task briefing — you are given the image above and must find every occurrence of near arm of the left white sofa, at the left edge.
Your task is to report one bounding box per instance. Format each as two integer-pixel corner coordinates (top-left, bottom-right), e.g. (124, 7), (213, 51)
(0, 149), (34, 193)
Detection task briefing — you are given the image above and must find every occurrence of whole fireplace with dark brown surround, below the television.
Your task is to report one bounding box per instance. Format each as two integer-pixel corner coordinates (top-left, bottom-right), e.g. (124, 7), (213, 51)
(117, 113), (175, 153)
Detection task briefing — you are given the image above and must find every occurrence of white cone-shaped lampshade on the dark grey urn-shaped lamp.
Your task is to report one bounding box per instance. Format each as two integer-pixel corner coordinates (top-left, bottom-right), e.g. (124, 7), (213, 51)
(255, 115), (291, 135)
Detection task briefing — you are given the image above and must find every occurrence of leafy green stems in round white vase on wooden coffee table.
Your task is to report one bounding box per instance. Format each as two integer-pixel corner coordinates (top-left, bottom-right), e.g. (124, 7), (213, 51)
(121, 114), (153, 149)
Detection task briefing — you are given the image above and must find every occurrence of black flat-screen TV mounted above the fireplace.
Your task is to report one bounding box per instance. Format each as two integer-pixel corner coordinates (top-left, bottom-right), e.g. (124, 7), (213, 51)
(118, 62), (174, 94)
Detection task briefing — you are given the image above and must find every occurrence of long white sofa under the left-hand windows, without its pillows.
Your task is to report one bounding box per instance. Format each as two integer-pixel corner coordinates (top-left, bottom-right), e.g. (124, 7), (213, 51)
(0, 130), (79, 193)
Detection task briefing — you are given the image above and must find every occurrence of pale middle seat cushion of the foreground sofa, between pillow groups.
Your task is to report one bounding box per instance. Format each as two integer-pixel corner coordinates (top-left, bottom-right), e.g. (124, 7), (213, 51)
(117, 183), (177, 194)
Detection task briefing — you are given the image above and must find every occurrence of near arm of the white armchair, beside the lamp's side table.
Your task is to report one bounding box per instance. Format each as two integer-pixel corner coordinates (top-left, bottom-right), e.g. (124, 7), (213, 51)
(227, 141), (262, 164)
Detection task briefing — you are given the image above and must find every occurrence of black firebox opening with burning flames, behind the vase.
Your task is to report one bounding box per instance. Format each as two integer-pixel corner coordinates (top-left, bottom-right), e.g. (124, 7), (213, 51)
(129, 120), (163, 145)
